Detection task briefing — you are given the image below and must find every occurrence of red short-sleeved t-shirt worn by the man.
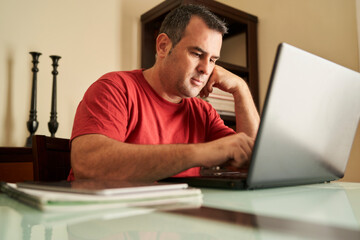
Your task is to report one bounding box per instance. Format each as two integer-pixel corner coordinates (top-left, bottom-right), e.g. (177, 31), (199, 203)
(69, 70), (235, 180)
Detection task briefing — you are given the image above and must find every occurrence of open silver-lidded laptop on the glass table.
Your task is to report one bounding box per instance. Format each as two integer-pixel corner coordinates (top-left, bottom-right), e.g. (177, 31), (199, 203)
(166, 43), (360, 189)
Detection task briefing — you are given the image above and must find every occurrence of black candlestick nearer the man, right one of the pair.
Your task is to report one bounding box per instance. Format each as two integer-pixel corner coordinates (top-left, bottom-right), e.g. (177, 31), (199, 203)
(48, 55), (61, 137)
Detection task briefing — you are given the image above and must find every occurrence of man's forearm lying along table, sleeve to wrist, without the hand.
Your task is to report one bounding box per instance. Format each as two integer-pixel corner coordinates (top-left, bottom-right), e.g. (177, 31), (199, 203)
(71, 135), (200, 181)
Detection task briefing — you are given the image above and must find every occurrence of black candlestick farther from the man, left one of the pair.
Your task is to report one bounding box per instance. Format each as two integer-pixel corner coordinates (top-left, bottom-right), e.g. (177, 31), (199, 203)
(26, 52), (41, 147)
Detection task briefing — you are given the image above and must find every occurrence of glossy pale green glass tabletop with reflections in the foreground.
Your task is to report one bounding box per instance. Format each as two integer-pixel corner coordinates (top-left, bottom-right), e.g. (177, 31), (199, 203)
(0, 183), (360, 240)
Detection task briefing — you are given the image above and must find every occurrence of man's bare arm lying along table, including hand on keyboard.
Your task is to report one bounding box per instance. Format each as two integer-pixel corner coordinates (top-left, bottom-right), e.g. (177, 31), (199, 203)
(71, 133), (254, 182)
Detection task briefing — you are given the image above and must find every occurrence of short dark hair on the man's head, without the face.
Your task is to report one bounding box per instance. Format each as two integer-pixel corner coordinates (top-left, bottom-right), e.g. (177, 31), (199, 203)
(159, 4), (228, 47)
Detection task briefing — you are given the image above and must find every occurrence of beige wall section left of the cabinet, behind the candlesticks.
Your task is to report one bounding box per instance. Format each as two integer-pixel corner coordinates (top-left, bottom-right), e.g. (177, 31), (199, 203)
(0, 0), (161, 146)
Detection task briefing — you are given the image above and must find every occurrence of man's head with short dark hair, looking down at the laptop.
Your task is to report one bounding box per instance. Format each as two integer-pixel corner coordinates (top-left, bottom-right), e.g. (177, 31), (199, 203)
(152, 5), (227, 103)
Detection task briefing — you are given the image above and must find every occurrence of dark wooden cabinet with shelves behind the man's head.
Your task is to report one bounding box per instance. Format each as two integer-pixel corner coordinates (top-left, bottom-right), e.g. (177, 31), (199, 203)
(141, 0), (259, 117)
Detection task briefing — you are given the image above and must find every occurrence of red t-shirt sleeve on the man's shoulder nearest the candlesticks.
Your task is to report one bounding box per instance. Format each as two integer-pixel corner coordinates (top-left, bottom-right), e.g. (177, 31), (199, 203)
(71, 79), (128, 141)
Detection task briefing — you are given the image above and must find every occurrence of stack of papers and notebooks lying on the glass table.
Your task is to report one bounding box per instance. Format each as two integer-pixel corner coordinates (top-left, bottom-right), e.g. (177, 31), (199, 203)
(0, 181), (202, 212)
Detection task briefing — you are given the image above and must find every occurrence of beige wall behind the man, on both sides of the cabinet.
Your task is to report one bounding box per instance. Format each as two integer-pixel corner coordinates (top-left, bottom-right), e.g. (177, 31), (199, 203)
(0, 0), (360, 181)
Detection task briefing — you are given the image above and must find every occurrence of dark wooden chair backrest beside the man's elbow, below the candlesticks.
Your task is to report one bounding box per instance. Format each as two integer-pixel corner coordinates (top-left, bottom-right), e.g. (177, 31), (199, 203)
(32, 135), (71, 181)
